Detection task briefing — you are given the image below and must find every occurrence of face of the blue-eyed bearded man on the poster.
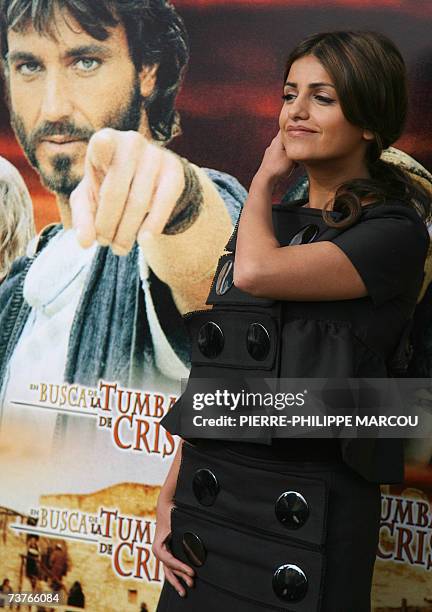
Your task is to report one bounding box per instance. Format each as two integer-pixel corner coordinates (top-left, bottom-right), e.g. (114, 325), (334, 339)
(7, 15), (142, 196)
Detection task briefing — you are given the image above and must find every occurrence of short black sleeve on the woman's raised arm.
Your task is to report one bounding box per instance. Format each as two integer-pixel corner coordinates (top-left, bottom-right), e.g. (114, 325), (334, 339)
(332, 203), (430, 306)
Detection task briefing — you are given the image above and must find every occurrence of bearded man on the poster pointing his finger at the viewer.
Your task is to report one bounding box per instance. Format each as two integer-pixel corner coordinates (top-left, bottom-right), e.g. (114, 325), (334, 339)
(0, 0), (245, 402)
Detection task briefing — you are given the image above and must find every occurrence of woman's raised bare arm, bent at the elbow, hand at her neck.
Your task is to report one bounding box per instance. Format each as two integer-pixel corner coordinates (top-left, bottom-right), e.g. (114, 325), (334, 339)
(234, 135), (367, 301)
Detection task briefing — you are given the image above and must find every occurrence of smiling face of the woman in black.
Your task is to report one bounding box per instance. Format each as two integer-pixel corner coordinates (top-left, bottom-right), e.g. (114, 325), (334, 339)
(279, 55), (374, 165)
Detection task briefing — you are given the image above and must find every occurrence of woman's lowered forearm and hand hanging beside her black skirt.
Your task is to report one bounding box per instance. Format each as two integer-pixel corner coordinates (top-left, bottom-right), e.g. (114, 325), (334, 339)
(152, 440), (194, 597)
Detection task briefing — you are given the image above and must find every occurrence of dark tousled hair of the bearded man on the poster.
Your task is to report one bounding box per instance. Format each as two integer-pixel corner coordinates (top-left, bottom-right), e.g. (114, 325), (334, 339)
(0, 0), (189, 142)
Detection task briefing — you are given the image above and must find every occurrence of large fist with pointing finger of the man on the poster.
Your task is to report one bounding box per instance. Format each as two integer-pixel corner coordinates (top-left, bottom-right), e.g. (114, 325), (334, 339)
(70, 128), (184, 255)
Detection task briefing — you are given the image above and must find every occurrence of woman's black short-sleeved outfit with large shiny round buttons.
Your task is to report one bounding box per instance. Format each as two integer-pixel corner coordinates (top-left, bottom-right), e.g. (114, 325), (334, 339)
(158, 201), (429, 612)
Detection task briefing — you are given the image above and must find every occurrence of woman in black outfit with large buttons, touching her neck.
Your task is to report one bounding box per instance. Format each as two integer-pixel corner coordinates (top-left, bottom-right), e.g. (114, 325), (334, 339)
(153, 32), (430, 612)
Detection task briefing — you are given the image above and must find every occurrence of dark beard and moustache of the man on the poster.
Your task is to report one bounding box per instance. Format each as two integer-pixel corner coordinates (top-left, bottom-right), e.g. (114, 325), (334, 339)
(11, 77), (143, 197)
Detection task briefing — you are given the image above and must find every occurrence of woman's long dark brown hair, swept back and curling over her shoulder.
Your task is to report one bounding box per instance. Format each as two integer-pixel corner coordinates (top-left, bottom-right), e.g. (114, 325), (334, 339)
(284, 32), (432, 228)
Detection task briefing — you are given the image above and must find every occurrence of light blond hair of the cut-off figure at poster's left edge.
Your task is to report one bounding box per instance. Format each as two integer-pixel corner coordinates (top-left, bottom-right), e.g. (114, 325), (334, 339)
(0, 157), (34, 281)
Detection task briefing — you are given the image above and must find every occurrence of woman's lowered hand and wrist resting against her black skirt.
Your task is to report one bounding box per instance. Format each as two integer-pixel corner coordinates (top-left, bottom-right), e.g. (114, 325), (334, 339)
(152, 497), (195, 597)
